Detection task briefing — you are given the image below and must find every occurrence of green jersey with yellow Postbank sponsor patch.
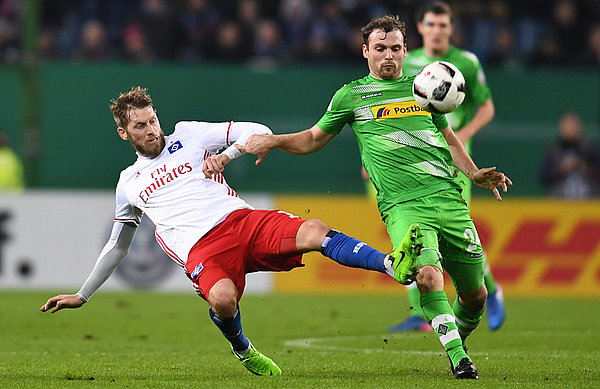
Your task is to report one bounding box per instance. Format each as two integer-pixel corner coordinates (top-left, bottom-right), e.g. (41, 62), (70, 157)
(317, 75), (458, 212)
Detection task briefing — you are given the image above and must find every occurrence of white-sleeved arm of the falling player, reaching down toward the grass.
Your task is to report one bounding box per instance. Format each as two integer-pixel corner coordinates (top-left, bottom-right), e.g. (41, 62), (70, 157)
(40, 222), (136, 313)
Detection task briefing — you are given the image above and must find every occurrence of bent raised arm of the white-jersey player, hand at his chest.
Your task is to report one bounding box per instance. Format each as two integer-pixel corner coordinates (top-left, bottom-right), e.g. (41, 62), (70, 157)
(202, 122), (273, 178)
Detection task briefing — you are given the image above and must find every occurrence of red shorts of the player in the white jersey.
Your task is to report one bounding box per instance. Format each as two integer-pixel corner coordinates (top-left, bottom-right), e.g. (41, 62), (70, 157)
(185, 209), (305, 301)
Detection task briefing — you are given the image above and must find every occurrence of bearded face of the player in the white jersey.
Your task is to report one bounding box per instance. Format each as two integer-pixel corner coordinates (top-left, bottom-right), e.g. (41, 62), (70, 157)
(117, 106), (165, 158)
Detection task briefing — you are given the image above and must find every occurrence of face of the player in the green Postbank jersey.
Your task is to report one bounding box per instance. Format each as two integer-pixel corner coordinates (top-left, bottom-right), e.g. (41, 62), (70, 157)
(363, 30), (406, 80)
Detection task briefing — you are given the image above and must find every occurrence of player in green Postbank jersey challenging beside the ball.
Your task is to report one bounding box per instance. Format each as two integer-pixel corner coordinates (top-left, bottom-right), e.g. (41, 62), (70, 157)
(238, 16), (512, 379)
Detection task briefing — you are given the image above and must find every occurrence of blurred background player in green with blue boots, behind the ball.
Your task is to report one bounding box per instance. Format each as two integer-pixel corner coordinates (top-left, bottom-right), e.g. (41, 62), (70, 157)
(389, 1), (506, 331)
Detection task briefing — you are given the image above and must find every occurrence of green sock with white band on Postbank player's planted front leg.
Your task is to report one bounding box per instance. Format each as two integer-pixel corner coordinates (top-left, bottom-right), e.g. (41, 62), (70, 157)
(421, 290), (468, 367)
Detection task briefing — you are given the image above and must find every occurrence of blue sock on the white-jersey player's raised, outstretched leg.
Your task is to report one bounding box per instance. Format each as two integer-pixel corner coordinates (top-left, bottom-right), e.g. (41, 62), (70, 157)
(321, 230), (387, 274)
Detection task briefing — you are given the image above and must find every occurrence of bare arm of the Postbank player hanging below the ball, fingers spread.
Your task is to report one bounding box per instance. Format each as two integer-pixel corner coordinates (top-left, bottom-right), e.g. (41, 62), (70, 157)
(440, 126), (512, 201)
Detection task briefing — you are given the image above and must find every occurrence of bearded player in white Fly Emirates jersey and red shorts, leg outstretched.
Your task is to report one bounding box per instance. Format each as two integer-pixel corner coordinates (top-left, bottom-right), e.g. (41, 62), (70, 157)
(40, 87), (422, 375)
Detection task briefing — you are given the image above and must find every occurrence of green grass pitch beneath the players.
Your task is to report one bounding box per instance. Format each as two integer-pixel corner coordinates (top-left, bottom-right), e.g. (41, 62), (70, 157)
(0, 291), (600, 389)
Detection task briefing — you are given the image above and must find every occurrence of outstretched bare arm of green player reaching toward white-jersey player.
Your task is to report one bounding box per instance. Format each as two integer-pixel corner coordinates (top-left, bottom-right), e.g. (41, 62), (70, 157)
(238, 124), (335, 166)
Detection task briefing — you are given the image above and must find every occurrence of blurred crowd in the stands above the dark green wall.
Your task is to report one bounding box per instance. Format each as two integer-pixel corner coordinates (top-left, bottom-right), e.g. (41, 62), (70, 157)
(0, 0), (600, 67)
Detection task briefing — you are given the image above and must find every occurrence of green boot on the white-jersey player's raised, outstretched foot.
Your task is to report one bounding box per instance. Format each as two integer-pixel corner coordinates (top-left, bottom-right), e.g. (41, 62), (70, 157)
(392, 223), (424, 285)
